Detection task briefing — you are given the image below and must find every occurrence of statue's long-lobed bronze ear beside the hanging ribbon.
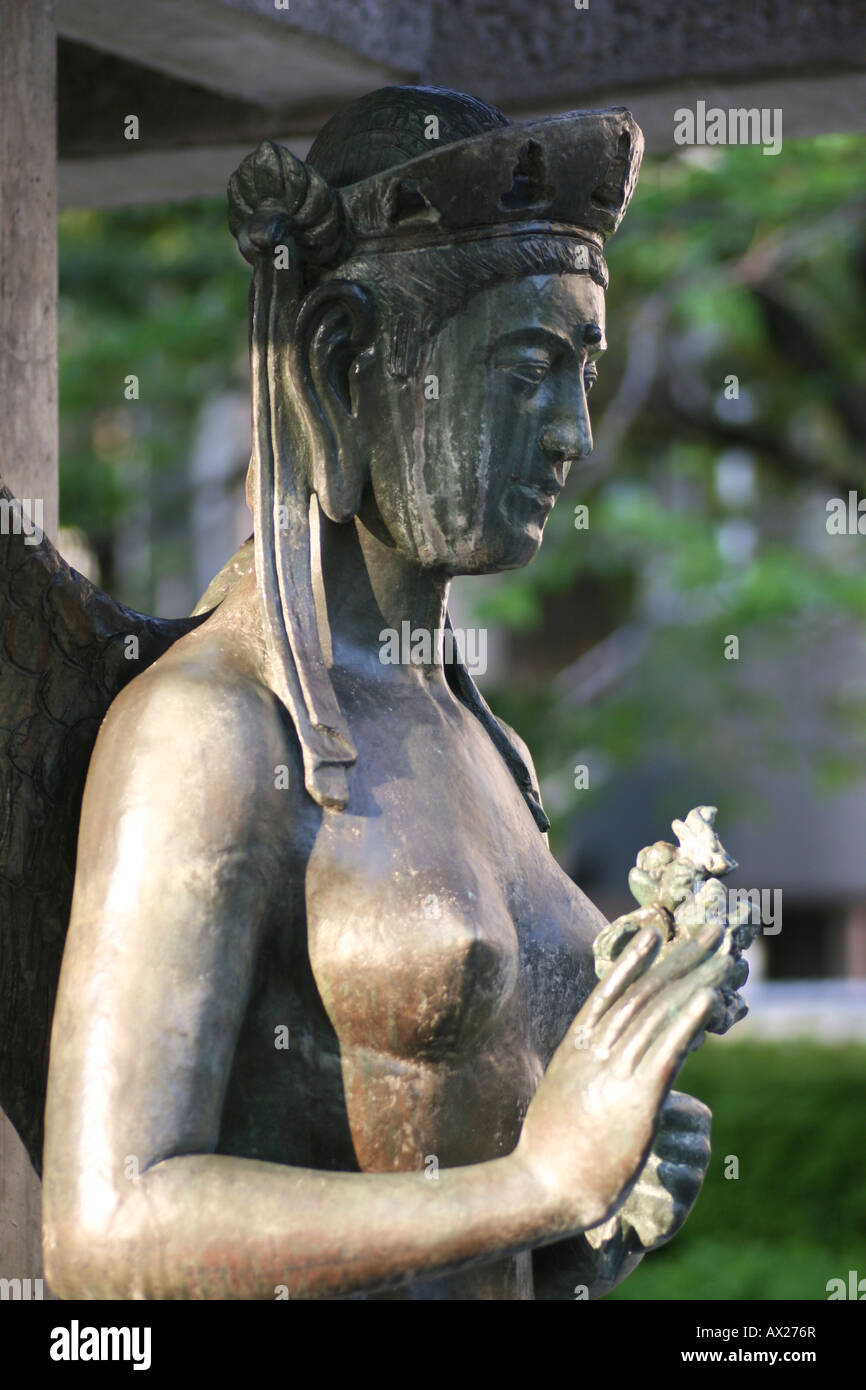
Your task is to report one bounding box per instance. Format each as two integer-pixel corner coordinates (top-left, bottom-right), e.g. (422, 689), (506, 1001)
(289, 279), (375, 521)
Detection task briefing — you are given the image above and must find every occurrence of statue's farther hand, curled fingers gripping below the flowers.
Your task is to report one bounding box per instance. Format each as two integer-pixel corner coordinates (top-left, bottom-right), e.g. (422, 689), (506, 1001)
(619, 1091), (712, 1251)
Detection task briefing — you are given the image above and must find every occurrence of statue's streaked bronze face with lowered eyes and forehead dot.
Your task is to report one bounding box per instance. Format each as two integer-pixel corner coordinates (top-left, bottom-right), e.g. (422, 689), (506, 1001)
(361, 275), (605, 574)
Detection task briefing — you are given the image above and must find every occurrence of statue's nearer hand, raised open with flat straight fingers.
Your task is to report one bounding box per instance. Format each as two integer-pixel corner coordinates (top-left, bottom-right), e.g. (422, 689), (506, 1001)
(517, 926), (721, 1232)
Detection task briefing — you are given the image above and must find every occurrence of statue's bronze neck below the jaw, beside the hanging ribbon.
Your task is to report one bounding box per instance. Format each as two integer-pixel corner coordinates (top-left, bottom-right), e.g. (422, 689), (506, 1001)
(311, 503), (450, 678)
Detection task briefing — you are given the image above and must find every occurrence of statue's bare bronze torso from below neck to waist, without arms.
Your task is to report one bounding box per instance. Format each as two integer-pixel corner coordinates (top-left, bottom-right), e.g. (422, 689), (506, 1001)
(195, 603), (605, 1298)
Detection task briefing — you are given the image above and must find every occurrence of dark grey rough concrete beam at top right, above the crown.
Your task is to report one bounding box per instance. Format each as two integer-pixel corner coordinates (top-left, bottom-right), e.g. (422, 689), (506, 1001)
(424, 0), (866, 110)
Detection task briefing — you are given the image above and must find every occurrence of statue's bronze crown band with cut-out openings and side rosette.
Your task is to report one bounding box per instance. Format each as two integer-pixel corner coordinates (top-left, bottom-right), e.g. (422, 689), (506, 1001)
(228, 107), (644, 279)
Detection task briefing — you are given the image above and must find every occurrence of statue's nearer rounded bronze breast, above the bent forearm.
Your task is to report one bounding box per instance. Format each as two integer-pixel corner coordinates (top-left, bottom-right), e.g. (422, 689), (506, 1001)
(307, 826), (520, 1061)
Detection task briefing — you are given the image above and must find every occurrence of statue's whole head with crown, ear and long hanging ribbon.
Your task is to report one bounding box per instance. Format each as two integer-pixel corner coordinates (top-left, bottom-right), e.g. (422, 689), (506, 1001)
(229, 88), (642, 805)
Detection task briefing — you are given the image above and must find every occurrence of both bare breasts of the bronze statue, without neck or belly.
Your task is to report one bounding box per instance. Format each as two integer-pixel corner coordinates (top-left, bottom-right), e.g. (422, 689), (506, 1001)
(306, 722), (601, 1062)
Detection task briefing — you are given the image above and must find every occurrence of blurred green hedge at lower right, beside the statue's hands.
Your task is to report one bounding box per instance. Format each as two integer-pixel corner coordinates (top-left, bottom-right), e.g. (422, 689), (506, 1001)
(609, 1038), (866, 1300)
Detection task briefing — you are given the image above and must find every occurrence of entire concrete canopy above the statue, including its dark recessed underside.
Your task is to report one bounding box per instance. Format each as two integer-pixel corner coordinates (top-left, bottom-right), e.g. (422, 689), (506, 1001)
(56, 0), (866, 206)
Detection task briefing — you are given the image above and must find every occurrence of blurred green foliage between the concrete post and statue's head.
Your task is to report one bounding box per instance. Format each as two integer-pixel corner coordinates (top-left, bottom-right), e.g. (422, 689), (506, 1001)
(58, 200), (249, 603)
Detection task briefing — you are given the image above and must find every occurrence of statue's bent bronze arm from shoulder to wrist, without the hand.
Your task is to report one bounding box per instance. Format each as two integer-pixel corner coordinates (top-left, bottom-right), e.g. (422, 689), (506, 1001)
(43, 670), (563, 1298)
